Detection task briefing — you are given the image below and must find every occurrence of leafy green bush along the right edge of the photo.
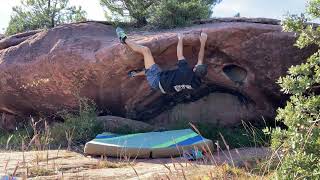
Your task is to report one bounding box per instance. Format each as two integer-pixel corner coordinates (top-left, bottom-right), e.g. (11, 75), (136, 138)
(272, 0), (320, 179)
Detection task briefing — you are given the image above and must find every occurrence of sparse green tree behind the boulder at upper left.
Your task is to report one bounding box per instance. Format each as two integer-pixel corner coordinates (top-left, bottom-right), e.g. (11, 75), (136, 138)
(6, 0), (86, 35)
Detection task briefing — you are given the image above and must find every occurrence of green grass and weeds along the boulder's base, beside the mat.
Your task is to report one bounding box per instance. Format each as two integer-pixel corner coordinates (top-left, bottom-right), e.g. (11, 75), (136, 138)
(0, 94), (270, 151)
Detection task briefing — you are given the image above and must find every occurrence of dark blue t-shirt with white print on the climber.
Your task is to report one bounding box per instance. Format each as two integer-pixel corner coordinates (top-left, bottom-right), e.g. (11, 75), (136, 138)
(160, 60), (201, 92)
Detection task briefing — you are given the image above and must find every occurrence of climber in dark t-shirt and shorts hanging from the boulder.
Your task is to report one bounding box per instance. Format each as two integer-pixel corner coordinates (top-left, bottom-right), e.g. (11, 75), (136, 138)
(116, 27), (208, 94)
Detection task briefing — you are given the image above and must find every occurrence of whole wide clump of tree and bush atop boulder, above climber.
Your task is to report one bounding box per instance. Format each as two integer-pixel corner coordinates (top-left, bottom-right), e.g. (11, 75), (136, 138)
(100, 0), (220, 28)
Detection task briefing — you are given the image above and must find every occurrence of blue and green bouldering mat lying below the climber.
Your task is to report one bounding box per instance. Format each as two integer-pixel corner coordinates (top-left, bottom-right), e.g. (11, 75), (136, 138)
(84, 129), (213, 158)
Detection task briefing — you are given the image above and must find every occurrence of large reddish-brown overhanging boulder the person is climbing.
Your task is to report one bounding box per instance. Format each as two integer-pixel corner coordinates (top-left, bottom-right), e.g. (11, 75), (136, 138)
(0, 20), (314, 128)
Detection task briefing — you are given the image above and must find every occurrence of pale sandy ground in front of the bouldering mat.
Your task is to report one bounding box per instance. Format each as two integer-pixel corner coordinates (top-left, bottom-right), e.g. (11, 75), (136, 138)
(0, 148), (270, 180)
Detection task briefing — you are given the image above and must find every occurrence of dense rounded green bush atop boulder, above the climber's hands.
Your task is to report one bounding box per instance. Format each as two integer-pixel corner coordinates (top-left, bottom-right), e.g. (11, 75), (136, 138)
(150, 0), (218, 28)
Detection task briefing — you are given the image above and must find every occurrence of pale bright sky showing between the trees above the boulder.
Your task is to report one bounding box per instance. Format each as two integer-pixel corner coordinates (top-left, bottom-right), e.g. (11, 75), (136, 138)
(0, 0), (307, 34)
